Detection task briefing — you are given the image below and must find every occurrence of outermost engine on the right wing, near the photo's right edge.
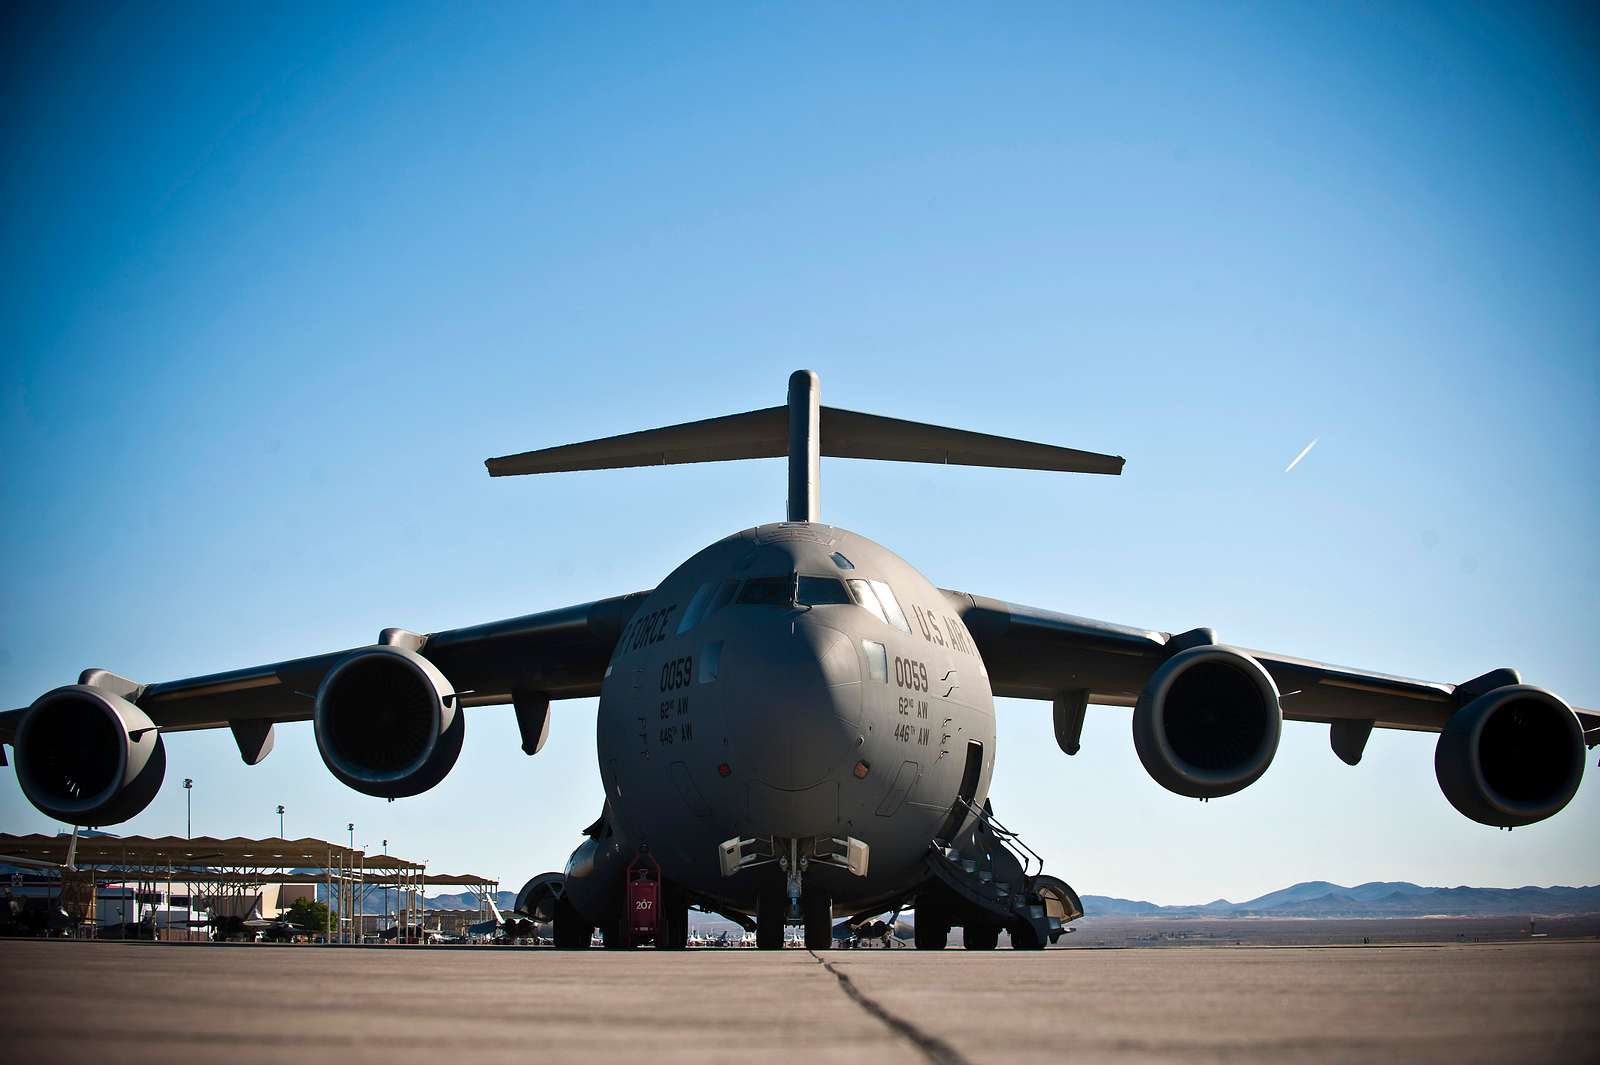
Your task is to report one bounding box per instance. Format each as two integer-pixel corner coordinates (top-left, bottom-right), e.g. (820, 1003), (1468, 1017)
(1434, 684), (1584, 828)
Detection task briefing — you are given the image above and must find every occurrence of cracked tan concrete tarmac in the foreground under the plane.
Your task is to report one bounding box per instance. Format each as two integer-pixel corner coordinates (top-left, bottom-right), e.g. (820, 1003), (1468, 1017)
(0, 940), (1600, 1065)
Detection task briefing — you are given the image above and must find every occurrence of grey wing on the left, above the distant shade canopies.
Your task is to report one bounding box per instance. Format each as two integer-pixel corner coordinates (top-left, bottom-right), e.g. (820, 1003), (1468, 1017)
(0, 592), (648, 744)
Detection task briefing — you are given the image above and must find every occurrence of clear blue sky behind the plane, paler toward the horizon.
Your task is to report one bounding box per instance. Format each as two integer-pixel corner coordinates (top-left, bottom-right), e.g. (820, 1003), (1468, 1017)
(0, 3), (1600, 902)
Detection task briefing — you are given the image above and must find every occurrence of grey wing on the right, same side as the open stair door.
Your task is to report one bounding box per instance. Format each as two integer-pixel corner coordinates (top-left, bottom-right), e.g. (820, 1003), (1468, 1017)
(944, 590), (1600, 747)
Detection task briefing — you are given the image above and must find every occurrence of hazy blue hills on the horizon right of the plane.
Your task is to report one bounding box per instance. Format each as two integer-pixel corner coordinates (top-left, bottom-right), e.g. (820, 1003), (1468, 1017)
(1083, 880), (1600, 918)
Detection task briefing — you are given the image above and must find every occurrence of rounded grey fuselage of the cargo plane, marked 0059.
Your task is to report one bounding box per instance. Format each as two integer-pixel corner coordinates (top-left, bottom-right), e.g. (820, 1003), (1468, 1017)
(566, 523), (995, 923)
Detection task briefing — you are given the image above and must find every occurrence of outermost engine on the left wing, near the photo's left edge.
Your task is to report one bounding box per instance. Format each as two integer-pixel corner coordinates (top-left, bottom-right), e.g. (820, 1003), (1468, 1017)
(16, 684), (166, 827)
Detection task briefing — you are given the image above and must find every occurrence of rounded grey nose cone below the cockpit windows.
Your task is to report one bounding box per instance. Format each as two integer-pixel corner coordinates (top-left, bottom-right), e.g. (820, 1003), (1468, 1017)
(725, 614), (861, 793)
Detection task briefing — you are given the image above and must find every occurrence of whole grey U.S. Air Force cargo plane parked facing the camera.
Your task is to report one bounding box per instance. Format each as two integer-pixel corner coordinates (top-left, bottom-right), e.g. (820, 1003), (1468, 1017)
(0, 371), (1600, 948)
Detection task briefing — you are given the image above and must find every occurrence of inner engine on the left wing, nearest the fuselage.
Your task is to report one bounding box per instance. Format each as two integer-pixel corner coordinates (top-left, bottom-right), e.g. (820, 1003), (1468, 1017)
(314, 646), (467, 798)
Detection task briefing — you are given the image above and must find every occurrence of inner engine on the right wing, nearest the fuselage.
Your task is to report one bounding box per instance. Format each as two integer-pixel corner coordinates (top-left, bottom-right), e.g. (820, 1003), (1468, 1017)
(1133, 644), (1283, 798)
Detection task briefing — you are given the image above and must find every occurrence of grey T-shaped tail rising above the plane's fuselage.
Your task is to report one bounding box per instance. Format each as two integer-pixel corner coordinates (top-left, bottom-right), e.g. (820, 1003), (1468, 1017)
(485, 369), (1123, 521)
